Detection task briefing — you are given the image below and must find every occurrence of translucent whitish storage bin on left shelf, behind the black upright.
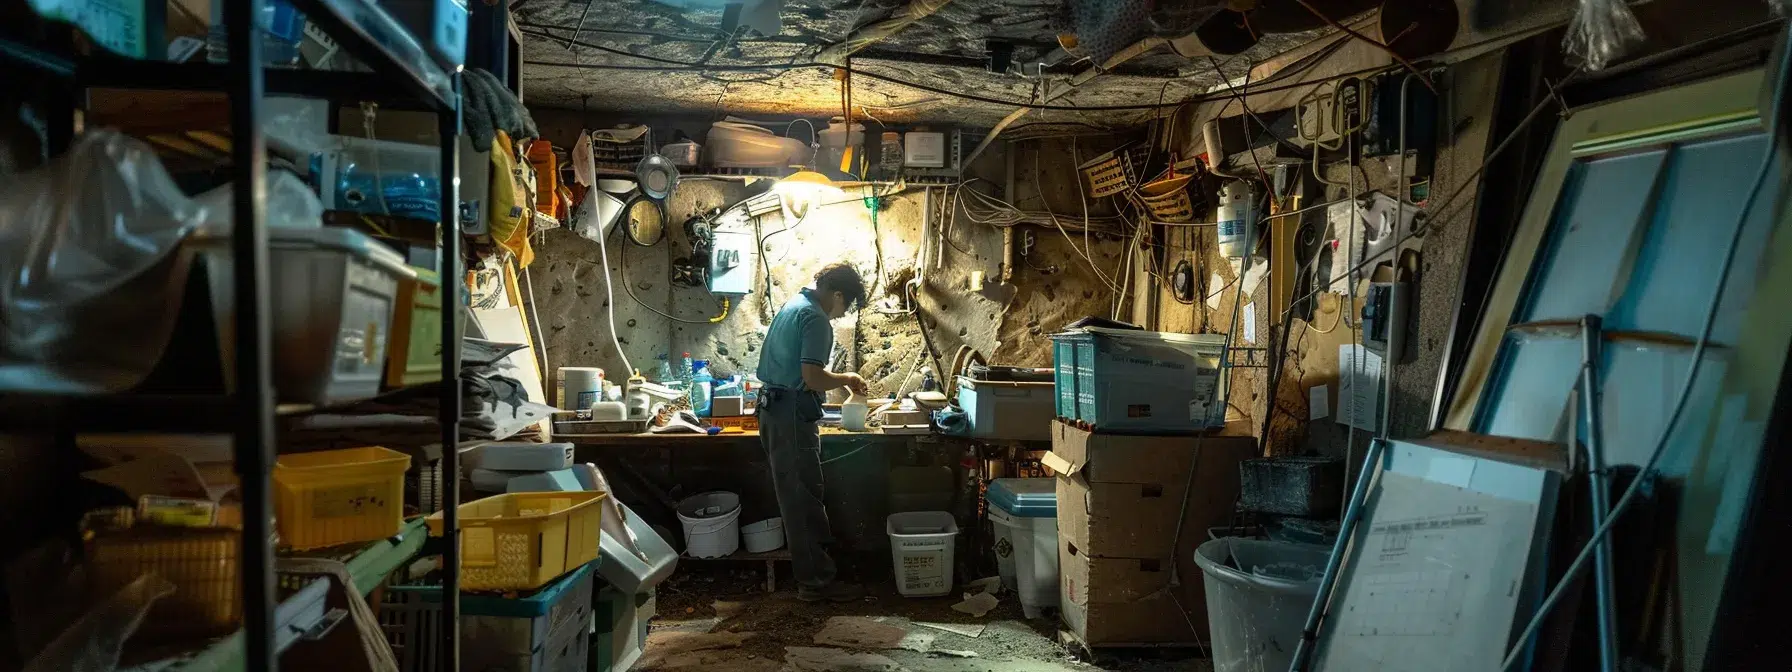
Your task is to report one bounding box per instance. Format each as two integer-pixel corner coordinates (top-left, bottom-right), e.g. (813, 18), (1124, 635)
(194, 228), (416, 403)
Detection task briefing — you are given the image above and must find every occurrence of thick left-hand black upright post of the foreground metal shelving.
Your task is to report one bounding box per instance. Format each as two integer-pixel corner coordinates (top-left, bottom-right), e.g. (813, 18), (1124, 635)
(224, 0), (280, 670)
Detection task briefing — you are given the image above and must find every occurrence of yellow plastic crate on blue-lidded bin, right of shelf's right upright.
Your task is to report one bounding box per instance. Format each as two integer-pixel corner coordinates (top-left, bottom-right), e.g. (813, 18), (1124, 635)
(428, 493), (604, 590)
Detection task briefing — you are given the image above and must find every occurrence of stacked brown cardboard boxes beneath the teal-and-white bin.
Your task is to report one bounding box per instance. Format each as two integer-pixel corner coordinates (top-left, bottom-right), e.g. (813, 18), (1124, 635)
(1045, 421), (1256, 647)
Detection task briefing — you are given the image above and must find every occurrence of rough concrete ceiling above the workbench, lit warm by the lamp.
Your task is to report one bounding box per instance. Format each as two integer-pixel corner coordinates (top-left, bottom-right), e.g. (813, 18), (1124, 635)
(514, 0), (1321, 127)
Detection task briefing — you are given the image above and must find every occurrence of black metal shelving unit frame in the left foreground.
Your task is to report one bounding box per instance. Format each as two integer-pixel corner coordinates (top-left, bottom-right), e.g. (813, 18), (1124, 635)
(0, 0), (461, 670)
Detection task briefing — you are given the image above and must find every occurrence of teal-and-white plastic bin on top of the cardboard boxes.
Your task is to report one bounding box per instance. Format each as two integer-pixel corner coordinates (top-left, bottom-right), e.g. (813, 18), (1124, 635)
(1052, 328), (1226, 432)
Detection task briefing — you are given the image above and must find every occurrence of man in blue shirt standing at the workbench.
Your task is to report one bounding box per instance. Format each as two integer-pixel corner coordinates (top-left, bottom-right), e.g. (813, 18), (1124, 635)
(758, 263), (866, 602)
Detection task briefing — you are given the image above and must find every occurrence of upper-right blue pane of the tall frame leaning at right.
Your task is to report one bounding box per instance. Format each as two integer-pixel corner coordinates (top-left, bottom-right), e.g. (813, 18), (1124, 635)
(1612, 134), (1778, 342)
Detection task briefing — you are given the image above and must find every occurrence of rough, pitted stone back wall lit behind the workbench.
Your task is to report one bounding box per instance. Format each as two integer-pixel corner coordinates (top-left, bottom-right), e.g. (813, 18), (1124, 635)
(527, 111), (1124, 394)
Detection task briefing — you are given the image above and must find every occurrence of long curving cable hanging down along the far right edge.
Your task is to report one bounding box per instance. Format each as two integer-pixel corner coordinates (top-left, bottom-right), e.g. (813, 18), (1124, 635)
(1500, 24), (1792, 670)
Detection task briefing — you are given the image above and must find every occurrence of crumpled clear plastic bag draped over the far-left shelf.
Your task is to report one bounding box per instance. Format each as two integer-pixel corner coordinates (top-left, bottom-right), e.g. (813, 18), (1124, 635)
(0, 129), (208, 394)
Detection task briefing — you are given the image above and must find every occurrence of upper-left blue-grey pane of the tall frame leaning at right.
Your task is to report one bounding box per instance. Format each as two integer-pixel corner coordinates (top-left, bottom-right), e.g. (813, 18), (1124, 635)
(1518, 151), (1667, 323)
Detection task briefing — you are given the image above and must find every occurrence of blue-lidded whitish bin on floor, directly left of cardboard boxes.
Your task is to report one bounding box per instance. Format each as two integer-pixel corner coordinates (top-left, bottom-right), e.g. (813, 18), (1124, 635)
(986, 478), (1057, 618)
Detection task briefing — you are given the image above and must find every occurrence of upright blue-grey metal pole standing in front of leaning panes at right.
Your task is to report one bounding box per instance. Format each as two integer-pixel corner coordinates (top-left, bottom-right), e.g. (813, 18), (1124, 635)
(1581, 315), (1618, 672)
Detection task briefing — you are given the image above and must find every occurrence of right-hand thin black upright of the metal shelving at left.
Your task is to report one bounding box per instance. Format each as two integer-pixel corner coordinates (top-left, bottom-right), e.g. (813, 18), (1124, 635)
(437, 72), (462, 672)
